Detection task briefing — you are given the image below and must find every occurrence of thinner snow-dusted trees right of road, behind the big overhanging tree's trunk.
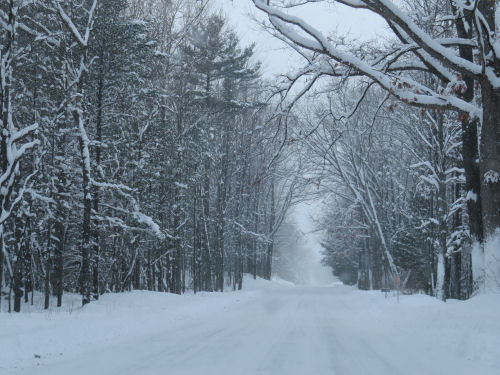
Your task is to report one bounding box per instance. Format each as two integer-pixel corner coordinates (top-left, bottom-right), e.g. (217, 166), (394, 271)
(308, 87), (472, 298)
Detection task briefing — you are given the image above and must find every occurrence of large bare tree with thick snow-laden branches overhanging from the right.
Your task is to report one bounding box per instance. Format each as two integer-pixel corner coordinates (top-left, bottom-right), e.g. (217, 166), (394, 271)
(254, 0), (500, 290)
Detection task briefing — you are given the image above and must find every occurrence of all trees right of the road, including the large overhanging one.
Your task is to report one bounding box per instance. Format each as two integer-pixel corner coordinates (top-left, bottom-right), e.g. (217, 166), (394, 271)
(254, 0), (500, 300)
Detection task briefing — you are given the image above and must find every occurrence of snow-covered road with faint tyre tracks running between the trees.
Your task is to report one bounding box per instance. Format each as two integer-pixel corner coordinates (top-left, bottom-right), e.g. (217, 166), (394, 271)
(4, 285), (498, 375)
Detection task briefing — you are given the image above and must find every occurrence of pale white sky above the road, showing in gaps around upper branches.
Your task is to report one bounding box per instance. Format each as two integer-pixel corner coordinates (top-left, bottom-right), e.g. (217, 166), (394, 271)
(212, 0), (386, 78)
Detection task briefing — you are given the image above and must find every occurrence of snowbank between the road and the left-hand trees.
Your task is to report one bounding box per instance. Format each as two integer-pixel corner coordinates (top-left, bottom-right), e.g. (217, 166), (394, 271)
(0, 279), (263, 375)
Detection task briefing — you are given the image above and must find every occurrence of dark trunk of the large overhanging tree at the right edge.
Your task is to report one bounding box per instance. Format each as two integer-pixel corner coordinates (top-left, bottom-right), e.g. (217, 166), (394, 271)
(452, 1), (500, 242)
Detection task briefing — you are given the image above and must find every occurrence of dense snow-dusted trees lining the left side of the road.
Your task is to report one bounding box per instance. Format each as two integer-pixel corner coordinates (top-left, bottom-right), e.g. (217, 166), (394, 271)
(0, 0), (293, 311)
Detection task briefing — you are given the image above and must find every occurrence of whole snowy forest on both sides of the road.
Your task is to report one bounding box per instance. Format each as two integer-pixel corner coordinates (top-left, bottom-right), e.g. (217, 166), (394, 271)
(0, 0), (500, 312)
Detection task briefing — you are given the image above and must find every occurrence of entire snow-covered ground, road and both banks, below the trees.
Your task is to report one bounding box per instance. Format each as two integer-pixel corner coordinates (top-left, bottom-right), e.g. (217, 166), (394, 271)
(0, 278), (500, 375)
